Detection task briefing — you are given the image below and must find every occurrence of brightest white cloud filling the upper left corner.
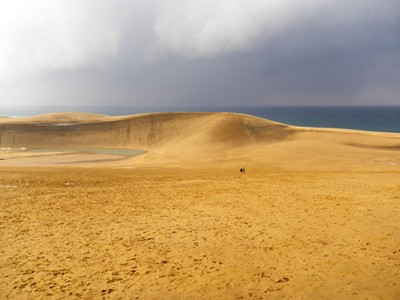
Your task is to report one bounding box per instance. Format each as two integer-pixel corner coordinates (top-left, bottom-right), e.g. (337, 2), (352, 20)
(0, 0), (128, 80)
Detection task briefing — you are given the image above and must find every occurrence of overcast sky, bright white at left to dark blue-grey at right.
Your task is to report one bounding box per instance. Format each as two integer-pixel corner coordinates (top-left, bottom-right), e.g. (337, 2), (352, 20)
(0, 0), (400, 106)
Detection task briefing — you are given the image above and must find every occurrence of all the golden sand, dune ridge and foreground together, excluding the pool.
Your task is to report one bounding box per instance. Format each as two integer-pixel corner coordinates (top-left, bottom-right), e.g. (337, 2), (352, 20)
(0, 114), (400, 299)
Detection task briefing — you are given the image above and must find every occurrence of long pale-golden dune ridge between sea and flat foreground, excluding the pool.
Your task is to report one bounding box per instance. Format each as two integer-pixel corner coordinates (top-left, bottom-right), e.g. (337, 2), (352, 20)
(0, 113), (400, 169)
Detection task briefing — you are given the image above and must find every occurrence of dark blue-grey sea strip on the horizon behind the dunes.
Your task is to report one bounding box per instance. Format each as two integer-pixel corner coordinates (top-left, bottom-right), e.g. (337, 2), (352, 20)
(0, 105), (400, 133)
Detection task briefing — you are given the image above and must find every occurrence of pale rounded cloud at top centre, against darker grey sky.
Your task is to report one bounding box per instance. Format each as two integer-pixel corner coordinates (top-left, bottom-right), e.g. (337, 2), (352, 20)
(154, 0), (325, 57)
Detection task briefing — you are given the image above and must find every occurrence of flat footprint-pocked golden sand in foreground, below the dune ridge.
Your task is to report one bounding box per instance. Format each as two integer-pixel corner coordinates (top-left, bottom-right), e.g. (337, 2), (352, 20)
(0, 168), (400, 299)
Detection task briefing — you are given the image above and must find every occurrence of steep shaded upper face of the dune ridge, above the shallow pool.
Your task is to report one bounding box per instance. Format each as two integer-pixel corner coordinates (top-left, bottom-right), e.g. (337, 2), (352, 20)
(0, 113), (293, 149)
